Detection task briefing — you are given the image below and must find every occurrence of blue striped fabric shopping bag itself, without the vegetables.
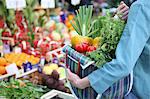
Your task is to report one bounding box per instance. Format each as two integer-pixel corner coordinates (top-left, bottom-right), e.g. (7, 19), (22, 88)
(63, 46), (133, 99)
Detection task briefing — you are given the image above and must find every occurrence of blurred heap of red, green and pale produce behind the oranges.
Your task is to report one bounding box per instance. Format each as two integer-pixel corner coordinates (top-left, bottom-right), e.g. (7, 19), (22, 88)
(0, 0), (74, 57)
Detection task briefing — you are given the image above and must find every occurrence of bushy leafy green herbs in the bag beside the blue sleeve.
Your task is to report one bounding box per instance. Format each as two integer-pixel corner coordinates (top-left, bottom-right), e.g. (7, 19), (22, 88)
(87, 14), (124, 67)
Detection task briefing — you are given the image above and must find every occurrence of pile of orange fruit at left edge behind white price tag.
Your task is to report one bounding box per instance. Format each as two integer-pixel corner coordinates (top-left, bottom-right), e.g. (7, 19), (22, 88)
(0, 53), (40, 75)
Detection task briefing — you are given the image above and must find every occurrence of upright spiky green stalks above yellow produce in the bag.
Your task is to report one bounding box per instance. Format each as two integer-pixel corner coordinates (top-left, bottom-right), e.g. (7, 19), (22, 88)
(71, 6), (98, 36)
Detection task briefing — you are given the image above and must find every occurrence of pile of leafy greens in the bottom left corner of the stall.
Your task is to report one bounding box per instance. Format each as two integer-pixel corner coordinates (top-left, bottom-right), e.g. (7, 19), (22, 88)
(0, 78), (47, 99)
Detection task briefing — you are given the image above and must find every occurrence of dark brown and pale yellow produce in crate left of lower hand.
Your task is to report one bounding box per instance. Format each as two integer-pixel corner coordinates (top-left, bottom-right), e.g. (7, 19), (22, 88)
(19, 64), (70, 93)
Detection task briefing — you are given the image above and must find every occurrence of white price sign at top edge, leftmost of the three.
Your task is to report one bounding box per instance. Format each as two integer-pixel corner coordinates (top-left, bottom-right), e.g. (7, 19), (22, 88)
(6, 0), (26, 9)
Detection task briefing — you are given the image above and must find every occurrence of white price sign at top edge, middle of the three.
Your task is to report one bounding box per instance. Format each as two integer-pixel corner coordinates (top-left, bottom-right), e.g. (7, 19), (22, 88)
(41, 0), (55, 8)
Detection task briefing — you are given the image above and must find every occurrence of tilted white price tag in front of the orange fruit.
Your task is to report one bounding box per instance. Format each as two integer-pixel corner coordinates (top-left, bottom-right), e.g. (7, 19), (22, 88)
(6, 63), (19, 75)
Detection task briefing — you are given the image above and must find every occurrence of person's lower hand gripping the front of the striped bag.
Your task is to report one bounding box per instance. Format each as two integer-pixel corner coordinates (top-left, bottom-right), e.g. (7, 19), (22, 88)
(67, 69), (90, 89)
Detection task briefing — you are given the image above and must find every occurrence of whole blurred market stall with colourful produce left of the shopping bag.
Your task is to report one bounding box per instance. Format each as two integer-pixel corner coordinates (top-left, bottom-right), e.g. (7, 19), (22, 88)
(0, 0), (76, 99)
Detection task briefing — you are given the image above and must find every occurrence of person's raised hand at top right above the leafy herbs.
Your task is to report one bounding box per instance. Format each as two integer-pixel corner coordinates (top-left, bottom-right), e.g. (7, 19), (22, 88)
(117, 1), (129, 20)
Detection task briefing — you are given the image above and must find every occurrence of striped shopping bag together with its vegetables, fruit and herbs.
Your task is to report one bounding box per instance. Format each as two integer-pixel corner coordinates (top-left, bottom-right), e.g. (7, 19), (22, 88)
(63, 6), (131, 99)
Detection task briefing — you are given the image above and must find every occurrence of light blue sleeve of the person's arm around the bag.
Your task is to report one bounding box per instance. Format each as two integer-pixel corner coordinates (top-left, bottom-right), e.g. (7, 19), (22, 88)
(88, 3), (150, 94)
